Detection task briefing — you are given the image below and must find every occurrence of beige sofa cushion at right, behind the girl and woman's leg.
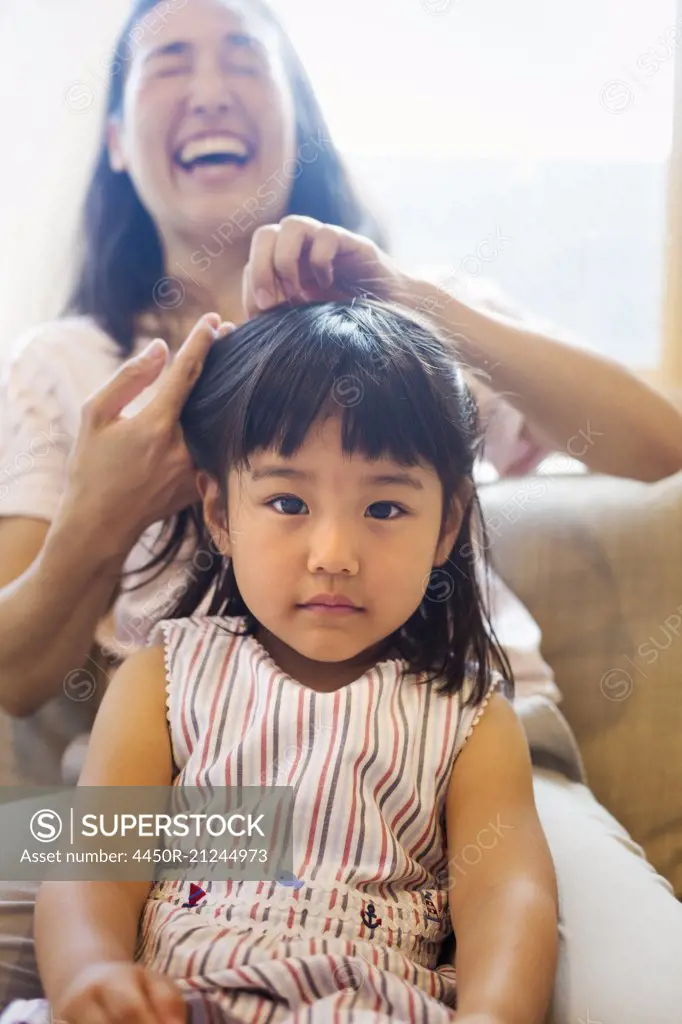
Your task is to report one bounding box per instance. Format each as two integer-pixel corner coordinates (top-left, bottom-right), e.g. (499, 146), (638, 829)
(481, 473), (682, 894)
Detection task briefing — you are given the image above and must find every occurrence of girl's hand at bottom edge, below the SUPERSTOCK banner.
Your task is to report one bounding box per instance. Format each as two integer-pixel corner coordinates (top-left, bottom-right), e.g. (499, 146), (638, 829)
(52, 963), (187, 1024)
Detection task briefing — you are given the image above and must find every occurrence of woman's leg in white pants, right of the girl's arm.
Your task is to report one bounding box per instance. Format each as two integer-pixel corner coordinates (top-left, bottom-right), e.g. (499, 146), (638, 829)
(534, 768), (682, 1024)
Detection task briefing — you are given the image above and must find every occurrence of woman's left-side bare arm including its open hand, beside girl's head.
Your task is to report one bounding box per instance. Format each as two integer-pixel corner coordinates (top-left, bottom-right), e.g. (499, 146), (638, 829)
(0, 313), (228, 717)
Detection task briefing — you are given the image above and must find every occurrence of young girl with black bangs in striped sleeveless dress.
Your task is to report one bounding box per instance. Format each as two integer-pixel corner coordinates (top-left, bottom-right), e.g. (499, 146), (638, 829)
(27, 300), (557, 1024)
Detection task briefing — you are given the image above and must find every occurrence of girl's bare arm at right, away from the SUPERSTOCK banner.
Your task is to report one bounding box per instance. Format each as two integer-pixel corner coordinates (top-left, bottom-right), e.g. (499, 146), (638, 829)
(445, 693), (558, 1024)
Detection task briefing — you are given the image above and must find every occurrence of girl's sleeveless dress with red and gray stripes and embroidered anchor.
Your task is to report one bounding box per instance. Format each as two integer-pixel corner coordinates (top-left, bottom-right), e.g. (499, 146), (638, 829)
(135, 614), (501, 1024)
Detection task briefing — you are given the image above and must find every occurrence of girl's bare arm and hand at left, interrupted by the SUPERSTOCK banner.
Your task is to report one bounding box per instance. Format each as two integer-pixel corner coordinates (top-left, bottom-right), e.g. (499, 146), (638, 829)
(36, 647), (183, 1022)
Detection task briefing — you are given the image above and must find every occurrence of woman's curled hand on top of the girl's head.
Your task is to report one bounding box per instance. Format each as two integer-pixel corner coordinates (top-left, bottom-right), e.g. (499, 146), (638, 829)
(242, 215), (413, 317)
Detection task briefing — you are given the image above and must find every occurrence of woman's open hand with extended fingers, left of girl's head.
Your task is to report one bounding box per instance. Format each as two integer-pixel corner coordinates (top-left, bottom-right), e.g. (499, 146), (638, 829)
(63, 313), (233, 556)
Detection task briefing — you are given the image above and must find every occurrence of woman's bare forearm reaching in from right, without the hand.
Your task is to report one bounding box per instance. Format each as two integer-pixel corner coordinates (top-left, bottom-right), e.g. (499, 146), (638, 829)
(411, 281), (682, 481)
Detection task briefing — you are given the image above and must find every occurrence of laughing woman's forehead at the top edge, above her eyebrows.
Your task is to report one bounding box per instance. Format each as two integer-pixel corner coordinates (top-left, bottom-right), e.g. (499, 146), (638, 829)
(128, 0), (269, 55)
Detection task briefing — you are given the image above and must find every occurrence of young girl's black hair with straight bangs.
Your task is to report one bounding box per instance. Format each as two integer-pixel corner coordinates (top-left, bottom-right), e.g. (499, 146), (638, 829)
(131, 299), (514, 703)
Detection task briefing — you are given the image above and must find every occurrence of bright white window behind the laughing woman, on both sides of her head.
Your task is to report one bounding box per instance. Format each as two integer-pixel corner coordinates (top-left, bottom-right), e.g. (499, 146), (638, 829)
(0, 0), (682, 380)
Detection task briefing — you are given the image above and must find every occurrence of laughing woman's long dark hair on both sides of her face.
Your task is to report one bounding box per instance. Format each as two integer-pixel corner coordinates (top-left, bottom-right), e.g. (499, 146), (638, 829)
(65, 0), (386, 356)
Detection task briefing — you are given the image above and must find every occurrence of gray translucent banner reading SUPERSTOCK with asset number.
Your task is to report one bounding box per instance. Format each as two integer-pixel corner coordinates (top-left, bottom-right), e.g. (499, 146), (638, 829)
(0, 785), (294, 882)
